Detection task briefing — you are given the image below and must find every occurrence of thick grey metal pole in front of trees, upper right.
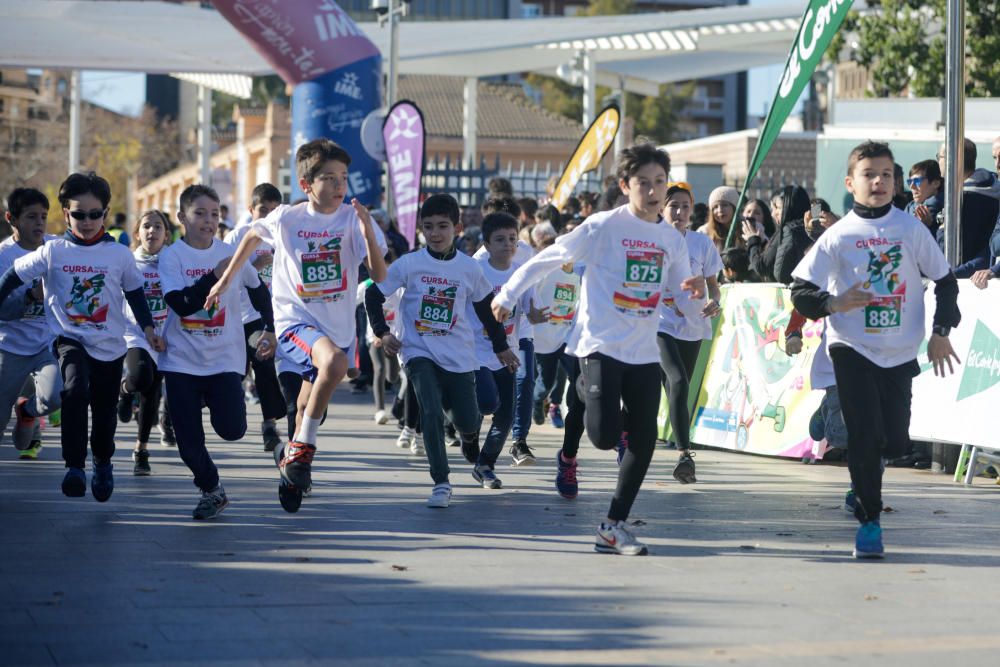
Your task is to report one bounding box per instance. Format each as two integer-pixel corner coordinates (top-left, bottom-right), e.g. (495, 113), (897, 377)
(944, 0), (965, 266)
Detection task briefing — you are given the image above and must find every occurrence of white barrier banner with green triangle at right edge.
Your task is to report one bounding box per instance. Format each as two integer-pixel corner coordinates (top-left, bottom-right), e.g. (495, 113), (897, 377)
(910, 280), (1000, 448)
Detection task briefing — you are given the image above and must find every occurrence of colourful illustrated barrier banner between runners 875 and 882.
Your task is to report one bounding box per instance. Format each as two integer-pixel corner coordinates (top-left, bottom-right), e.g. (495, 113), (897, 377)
(691, 284), (823, 457)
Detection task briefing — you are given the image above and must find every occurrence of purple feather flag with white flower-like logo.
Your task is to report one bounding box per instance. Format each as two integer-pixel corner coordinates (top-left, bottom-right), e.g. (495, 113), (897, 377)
(382, 100), (425, 249)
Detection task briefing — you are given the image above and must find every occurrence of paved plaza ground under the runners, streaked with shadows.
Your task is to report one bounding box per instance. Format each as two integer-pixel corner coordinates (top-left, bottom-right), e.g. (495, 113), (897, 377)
(0, 390), (1000, 667)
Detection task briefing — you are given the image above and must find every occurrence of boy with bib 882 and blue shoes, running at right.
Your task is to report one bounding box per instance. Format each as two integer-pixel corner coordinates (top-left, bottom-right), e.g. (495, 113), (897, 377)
(792, 142), (961, 558)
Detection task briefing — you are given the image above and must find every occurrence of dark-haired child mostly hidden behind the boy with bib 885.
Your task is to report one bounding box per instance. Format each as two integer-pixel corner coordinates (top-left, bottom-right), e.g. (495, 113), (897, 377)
(223, 183), (287, 452)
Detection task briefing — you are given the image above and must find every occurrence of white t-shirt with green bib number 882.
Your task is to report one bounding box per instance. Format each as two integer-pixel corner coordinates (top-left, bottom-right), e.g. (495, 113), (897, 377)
(792, 208), (950, 368)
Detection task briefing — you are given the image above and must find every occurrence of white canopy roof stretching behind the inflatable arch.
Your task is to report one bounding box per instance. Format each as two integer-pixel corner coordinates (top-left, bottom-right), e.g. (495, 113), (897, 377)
(0, 0), (802, 174)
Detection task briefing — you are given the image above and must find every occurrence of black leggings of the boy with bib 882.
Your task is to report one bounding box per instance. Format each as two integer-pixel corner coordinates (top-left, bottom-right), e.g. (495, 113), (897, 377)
(830, 345), (920, 521)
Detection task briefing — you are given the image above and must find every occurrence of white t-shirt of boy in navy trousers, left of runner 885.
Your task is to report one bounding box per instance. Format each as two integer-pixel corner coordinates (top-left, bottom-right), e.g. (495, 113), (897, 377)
(157, 239), (260, 375)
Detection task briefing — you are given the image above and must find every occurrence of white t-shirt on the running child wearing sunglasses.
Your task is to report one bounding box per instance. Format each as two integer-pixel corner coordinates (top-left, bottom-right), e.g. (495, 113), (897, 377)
(14, 238), (142, 361)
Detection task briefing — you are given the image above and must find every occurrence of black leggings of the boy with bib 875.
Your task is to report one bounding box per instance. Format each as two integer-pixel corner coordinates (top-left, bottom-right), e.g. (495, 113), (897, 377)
(580, 353), (660, 521)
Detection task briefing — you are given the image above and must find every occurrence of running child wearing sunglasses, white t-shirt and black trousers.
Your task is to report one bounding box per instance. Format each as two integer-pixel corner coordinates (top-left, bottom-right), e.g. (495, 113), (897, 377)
(0, 172), (164, 502)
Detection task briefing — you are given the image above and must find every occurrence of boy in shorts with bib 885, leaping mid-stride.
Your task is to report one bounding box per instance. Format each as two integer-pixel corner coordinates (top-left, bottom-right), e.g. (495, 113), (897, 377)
(206, 139), (387, 512)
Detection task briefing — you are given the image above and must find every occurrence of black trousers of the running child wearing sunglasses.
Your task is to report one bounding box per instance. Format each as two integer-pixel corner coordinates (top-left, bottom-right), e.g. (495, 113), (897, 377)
(55, 336), (125, 468)
